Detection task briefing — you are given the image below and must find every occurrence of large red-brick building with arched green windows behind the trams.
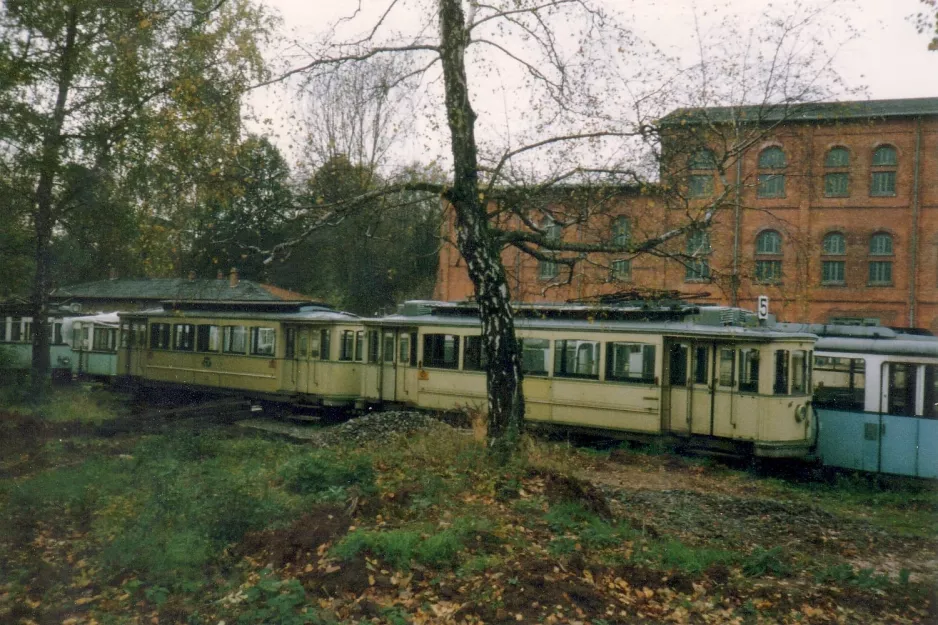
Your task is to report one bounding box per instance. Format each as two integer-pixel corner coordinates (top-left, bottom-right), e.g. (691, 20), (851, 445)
(435, 98), (938, 333)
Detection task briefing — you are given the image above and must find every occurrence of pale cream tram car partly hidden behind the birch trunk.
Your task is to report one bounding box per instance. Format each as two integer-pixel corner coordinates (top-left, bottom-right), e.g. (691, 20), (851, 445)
(361, 302), (816, 457)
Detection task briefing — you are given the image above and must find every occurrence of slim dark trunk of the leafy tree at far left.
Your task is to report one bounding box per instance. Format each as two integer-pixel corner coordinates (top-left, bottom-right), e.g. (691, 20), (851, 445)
(30, 6), (78, 398)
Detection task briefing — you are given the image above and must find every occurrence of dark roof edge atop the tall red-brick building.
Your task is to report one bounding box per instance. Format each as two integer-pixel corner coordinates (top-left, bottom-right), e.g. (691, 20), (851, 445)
(661, 98), (938, 126)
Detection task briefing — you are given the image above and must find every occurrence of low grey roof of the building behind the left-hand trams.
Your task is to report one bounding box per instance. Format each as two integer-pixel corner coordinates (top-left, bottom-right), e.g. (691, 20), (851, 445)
(52, 277), (310, 302)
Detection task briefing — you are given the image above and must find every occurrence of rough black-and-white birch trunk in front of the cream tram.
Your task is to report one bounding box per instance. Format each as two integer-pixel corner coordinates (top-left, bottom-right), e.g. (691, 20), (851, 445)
(439, 0), (524, 461)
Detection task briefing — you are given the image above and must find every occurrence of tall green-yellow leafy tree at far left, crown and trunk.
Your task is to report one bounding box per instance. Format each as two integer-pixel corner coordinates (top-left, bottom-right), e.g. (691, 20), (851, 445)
(0, 0), (270, 389)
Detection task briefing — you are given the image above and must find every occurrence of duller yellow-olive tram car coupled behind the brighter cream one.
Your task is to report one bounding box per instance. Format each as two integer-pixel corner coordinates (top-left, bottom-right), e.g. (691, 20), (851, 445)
(117, 302), (364, 407)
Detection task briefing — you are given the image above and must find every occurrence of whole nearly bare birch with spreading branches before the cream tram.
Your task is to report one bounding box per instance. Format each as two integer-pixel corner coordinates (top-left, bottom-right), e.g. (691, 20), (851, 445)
(258, 0), (856, 457)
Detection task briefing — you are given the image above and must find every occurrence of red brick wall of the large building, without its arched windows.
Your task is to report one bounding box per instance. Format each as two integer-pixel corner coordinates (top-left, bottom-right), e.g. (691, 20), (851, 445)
(435, 118), (938, 333)
